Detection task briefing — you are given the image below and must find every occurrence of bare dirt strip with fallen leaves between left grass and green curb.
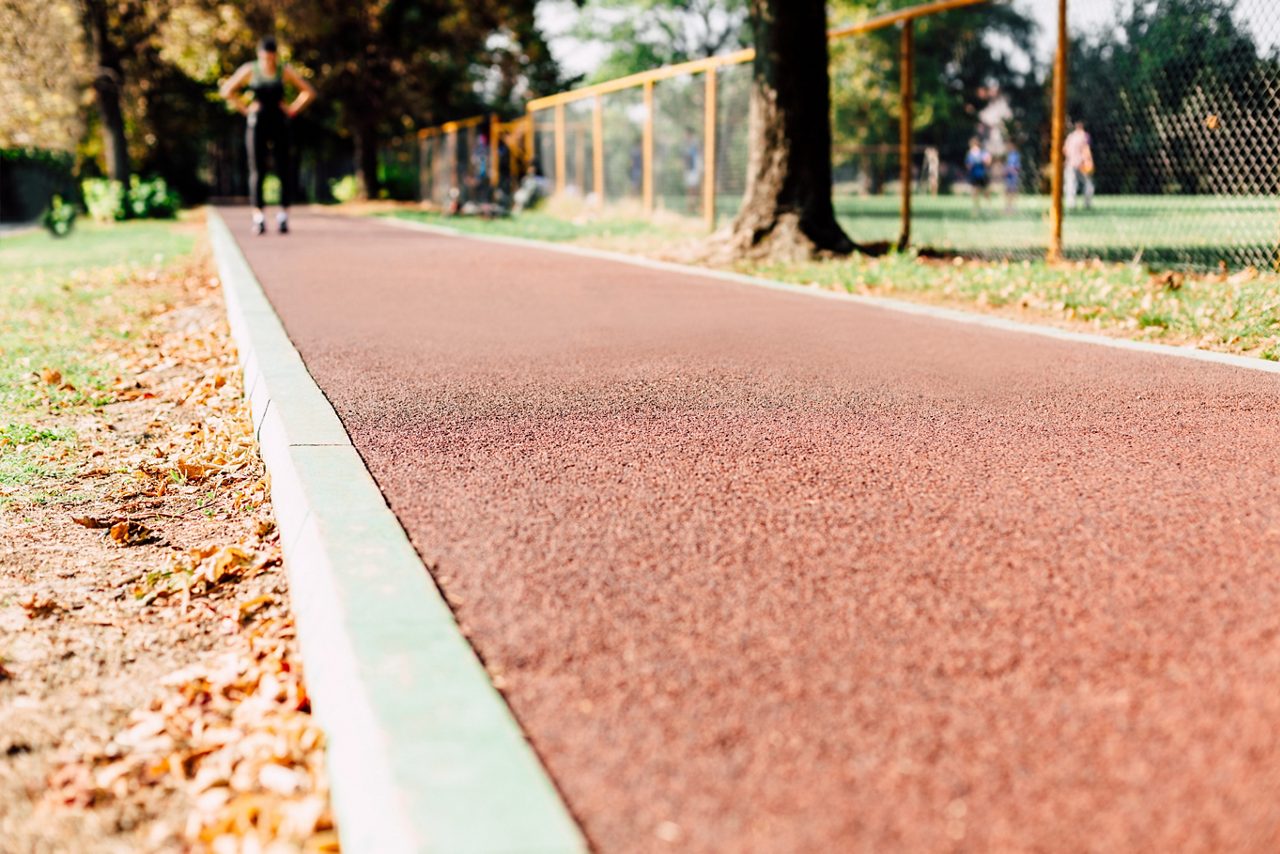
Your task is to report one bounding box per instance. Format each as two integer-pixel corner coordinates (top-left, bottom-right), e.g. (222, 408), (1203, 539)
(0, 225), (337, 851)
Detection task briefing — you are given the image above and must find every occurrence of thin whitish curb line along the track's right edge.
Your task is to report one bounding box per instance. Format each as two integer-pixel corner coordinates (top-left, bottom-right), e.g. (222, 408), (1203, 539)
(366, 214), (1280, 374)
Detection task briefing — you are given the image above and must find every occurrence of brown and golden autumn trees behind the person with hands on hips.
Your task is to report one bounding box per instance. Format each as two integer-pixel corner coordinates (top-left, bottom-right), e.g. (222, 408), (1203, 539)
(0, 0), (562, 198)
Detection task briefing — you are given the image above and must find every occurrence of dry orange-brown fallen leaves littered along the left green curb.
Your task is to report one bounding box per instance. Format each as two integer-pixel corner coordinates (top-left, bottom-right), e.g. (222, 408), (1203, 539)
(0, 222), (338, 853)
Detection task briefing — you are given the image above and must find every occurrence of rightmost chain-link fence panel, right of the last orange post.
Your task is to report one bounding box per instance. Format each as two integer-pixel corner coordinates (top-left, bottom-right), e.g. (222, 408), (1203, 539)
(1062, 0), (1280, 269)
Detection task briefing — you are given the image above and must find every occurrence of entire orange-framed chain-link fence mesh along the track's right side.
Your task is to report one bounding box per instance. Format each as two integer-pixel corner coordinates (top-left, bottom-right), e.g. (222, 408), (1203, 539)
(421, 0), (1280, 269)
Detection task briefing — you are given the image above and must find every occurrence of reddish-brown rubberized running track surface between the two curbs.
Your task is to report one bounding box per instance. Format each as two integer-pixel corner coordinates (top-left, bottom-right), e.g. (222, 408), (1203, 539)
(235, 211), (1280, 851)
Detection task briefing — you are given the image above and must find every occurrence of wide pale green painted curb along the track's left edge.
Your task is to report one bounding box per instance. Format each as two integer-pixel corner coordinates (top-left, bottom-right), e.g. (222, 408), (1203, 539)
(207, 209), (586, 854)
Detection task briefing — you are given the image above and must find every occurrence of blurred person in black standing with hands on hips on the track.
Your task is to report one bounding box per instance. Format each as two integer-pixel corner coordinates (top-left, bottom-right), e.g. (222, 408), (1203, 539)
(220, 36), (316, 234)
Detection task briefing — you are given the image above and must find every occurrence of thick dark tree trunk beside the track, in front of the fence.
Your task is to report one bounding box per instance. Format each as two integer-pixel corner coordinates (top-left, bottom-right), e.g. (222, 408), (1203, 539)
(730, 0), (855, 259)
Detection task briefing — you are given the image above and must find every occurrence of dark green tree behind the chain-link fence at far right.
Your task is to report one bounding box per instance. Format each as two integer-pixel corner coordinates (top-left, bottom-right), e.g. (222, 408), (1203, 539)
(1069, 0), (1280, 193)
